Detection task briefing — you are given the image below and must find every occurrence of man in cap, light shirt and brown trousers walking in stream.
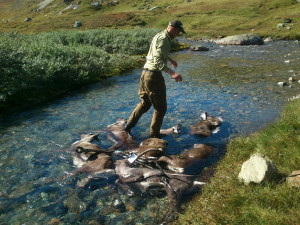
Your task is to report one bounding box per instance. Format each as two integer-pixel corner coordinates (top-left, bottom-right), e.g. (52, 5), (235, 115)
(124, 20), (185, 138)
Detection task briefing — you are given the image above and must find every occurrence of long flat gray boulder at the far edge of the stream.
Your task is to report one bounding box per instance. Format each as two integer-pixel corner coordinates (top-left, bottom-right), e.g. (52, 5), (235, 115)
(216, 34), (264, 45)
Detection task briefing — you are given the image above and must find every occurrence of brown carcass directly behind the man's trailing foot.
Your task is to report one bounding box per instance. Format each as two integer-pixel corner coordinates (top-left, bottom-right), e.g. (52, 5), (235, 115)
(107, 118), (137, 150)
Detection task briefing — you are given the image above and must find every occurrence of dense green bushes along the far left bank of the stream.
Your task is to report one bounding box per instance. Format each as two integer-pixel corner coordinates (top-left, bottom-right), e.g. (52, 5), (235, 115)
(0, 29), (177, 111)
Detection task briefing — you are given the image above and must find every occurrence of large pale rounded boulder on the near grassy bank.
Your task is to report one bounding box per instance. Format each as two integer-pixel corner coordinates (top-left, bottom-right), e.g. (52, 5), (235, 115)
(239, 153), (278, 184)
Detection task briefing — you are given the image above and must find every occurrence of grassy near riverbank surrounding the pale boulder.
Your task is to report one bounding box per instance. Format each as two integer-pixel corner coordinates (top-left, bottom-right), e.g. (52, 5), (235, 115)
(174, 99), (300, 224)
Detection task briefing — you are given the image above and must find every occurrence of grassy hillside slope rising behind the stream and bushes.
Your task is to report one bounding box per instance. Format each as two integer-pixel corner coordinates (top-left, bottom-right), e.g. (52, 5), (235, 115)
(0, 0), (300, 39)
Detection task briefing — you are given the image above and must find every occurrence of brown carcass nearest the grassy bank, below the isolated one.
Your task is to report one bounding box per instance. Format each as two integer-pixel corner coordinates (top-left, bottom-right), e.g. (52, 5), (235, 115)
(157, 144), (213, 173)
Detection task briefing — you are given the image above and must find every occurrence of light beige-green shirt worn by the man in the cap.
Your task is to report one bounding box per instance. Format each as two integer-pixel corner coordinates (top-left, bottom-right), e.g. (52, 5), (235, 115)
(144, 30), (171, 71)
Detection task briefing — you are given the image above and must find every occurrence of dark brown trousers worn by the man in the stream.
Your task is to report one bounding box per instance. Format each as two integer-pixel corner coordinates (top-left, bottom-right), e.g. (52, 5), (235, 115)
(128, 70), (167, 137)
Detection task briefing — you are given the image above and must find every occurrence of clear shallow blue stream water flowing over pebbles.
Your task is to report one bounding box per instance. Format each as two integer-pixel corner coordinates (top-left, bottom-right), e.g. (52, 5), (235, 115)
(0, 41), (300, 224)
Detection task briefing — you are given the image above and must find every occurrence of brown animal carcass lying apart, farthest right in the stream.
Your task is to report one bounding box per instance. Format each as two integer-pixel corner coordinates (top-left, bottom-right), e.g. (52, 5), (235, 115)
(190, 112), (223, 137)
